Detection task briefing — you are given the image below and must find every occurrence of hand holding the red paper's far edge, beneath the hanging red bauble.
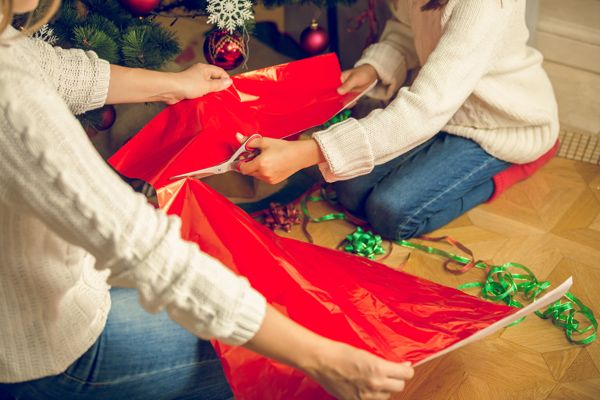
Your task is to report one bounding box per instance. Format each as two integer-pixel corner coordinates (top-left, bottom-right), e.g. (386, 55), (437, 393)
(165, 63), (233, 104)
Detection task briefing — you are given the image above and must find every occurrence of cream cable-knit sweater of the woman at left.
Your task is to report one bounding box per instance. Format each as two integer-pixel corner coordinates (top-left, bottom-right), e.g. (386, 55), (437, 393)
(0, 29), (266, 382)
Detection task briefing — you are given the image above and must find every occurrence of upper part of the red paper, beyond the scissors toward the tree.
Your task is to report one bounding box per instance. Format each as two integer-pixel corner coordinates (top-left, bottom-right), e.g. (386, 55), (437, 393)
(109, 54), (360, 188)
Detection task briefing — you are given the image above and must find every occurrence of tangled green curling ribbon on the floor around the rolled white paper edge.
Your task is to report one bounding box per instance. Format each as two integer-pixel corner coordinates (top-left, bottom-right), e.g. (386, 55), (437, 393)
(395, 240), (598, 345)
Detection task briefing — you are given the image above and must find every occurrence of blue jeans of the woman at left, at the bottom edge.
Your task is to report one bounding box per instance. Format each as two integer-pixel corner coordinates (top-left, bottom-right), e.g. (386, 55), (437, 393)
(0, 288), (233, 400)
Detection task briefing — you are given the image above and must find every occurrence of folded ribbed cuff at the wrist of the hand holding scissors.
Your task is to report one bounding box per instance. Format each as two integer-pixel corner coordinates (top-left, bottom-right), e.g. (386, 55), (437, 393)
(313, 118), (374, 182)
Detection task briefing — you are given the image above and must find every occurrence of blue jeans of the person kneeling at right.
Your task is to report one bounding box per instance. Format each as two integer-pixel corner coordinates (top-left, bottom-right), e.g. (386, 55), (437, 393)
(333, 132), (511, 240)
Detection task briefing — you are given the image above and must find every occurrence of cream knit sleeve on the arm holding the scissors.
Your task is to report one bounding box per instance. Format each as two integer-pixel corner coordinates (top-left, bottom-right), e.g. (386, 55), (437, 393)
(314, 0), (514, 182)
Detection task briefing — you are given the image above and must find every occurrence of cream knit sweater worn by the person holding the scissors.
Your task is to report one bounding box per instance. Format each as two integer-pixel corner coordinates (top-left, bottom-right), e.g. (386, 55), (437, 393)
(314, 0), (559, 181)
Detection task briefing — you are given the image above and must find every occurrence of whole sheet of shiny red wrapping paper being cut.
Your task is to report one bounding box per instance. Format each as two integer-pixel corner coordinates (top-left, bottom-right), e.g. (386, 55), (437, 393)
(110, 55), (515, 400)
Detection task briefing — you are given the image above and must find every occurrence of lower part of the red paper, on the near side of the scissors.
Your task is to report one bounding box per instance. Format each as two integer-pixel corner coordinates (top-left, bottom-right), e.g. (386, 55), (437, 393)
(159, 179), (516, 400)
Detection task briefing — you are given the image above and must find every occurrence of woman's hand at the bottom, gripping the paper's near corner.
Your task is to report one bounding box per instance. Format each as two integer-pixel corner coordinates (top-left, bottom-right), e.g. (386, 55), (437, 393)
(303, 341), (414, 400)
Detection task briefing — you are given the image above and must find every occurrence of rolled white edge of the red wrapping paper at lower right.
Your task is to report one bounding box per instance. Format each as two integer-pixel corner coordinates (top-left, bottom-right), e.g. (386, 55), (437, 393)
(413, 277), (573, 367)
